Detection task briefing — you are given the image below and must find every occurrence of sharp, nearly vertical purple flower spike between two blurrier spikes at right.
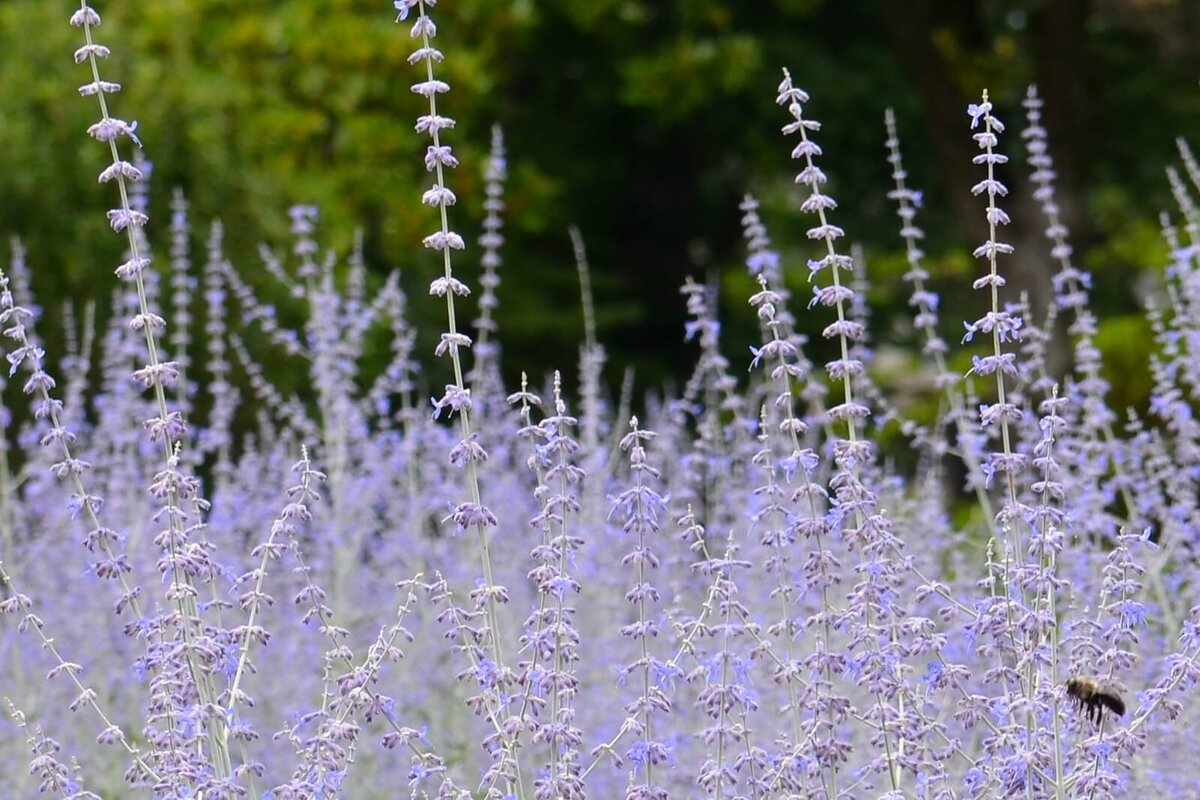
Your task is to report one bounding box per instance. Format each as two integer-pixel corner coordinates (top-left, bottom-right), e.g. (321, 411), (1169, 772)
(964, 91), (1027, 532)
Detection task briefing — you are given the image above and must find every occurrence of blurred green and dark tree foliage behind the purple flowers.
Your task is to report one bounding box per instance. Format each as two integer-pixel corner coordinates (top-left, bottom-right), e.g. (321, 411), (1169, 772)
(0, 0), (1200, 408)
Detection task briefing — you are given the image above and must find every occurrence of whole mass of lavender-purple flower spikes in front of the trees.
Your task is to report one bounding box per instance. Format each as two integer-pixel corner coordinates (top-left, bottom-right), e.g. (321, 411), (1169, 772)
(0, 0), (1200, 800)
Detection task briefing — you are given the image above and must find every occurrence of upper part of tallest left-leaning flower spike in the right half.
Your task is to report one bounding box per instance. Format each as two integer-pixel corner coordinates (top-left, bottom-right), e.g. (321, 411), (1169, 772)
(775, 70), (870, 429)
